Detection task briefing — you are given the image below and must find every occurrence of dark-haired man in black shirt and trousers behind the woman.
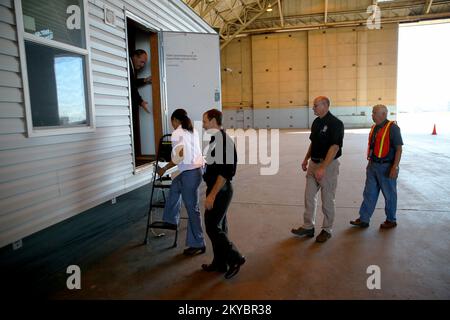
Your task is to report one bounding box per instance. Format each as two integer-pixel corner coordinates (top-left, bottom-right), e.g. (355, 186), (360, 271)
(202, 109), (245, 279)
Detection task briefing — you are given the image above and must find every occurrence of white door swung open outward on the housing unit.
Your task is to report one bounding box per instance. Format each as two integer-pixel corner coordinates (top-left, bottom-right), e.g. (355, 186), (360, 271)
(163, 32), (222, 131)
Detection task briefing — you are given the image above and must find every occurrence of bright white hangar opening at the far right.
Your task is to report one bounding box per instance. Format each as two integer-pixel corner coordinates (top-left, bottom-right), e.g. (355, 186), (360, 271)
(397, 20), (450, 134)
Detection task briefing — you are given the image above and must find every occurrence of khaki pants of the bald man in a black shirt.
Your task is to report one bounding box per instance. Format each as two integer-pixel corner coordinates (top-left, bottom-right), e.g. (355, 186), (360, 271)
(303, 160), (339, 233)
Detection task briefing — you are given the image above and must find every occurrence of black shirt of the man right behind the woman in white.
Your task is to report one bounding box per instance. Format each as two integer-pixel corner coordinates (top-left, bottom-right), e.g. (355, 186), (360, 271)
(203, 130), (237, 187)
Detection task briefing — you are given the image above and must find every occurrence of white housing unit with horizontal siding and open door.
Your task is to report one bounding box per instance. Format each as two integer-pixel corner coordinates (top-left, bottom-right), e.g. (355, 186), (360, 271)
(0, 0), (221, 247)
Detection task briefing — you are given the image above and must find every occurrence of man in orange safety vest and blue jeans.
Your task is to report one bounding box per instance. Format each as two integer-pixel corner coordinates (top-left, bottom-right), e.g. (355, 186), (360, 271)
(350, 104), (403, 229)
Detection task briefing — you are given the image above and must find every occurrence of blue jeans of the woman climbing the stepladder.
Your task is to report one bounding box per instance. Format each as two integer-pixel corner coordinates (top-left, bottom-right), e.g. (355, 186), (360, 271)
(163, 168), (205, 248)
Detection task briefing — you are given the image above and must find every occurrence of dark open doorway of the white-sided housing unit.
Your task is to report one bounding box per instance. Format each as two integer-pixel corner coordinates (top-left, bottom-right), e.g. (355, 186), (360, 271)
(127, 17), (162, 169)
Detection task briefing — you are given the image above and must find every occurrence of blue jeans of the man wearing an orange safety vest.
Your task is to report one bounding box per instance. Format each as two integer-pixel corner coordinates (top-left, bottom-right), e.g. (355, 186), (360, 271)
(359, 162), (397, 223)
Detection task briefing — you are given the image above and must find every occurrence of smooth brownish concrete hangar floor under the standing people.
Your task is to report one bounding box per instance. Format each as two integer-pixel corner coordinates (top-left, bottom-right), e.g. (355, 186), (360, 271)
(53, 130), (450, 299)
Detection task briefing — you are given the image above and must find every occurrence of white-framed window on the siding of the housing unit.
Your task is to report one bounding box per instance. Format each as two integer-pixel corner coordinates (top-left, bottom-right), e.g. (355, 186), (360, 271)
(15, 0), (93, 135)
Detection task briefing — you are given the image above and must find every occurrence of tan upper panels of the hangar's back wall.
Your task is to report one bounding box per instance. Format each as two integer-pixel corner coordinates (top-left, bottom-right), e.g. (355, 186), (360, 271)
(223, 24), (398, 125)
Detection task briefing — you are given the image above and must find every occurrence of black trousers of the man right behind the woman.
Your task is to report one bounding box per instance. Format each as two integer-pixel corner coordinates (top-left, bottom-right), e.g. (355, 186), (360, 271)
(205, 181), (241, 266)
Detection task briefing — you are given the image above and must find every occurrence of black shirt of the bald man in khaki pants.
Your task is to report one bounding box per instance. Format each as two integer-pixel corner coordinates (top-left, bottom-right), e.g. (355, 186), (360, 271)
(309, 112), (344, 161)
